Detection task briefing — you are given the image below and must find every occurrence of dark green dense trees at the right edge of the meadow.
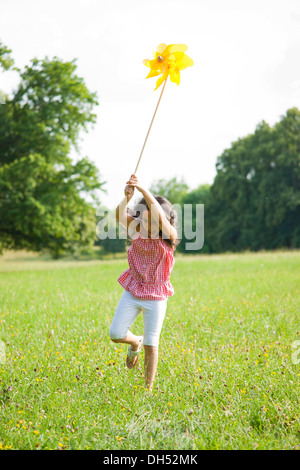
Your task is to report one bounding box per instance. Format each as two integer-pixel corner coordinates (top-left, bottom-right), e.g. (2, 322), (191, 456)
(209, 108), (300, 252)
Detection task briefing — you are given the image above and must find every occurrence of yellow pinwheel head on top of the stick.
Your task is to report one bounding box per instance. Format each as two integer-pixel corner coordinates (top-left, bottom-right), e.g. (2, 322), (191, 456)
(143, 44), (194, 90)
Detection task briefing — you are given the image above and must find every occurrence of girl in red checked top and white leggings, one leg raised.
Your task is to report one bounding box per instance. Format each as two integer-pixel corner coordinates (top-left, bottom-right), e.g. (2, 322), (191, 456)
(109, 175), (179, 391)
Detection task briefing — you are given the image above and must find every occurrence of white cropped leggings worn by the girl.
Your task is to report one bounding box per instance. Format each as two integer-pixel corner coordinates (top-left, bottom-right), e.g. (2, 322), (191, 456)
(109, 290), (168, 347)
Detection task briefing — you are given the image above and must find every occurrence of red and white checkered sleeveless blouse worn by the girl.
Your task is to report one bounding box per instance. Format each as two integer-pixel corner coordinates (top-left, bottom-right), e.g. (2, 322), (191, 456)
(118, 234), (175, 300)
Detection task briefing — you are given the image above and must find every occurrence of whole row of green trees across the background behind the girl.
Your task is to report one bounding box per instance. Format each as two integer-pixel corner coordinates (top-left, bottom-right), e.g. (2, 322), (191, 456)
(0, 42), (300, 258)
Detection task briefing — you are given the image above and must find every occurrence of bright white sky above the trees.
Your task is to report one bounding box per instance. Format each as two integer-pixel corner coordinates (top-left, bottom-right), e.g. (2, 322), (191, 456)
(0, 0), (300, 208)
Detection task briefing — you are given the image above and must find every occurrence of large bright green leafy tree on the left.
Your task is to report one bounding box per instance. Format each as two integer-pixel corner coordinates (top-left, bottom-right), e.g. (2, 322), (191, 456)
(0, 40), (104, 257)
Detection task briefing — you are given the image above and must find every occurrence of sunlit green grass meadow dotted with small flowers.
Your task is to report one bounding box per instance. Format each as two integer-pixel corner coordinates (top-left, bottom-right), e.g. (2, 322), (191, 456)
(0, 251), (300, 450)
